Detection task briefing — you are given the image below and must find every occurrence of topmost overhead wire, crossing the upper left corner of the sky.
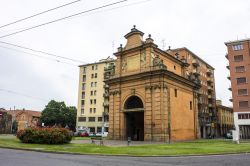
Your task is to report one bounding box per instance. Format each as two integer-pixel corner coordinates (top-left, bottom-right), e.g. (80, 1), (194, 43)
(0, 0), (81, 28)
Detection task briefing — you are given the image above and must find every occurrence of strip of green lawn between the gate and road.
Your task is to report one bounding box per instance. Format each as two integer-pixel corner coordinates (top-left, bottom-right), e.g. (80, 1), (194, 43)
(0, 137), (250, 156)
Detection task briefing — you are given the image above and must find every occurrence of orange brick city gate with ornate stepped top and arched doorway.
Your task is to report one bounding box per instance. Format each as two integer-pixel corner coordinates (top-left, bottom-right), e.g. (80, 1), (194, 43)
(106, 26), (200, 141)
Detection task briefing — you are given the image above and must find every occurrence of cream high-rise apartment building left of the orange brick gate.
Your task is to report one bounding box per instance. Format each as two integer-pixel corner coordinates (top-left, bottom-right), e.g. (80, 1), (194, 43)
(76, 57), (114, 133)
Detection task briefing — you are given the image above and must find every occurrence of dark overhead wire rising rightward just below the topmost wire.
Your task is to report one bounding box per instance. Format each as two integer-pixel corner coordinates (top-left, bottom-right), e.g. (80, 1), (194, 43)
(0, 0), (129, 38)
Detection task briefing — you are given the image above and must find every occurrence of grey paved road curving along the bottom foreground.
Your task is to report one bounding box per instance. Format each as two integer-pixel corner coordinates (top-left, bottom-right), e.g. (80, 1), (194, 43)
(0, 148), (250, 166)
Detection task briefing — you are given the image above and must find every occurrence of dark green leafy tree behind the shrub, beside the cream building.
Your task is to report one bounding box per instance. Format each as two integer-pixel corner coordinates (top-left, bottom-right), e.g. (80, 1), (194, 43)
(41, 100), (77, 130)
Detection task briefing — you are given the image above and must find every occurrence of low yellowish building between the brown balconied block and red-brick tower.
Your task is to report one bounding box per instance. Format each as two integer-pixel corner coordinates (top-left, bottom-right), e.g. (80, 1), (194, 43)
(216, 100), (234, 137)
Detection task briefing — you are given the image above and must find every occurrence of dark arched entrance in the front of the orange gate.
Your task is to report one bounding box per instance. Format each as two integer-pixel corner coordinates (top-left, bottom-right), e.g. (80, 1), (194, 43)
(124, 96), (144, 141)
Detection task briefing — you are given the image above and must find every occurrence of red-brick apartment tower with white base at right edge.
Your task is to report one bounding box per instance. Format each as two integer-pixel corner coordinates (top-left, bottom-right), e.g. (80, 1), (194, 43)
(225, 39), (250, 139)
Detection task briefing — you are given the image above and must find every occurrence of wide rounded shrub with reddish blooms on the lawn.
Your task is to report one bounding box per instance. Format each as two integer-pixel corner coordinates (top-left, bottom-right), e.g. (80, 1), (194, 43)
(17, 128), (72, 144)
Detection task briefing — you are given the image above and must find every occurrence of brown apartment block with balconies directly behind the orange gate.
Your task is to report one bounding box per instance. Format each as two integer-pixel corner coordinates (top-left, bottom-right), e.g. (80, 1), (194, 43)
(167, 47), (218, 138)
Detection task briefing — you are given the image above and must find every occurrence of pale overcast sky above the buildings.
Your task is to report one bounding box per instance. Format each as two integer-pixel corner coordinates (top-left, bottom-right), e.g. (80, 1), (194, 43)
(0, 0), (250, 111)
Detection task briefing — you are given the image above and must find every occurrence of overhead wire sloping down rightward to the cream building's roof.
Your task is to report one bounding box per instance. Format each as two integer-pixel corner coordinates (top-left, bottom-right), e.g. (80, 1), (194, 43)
(0, 41), (86, 64)
